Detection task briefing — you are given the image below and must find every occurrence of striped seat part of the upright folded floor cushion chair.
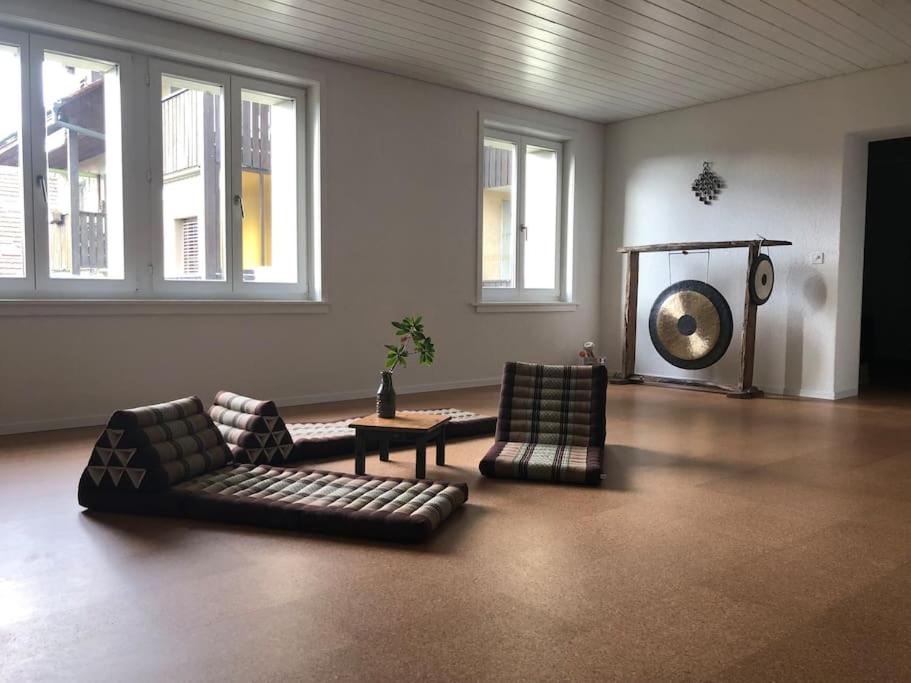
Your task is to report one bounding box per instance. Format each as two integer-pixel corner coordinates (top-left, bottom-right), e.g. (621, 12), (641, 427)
(479, 441), (604, 485)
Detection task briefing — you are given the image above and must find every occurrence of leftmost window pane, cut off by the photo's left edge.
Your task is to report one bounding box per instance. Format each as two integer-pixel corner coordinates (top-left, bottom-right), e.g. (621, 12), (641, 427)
(0, 45), (25, 278)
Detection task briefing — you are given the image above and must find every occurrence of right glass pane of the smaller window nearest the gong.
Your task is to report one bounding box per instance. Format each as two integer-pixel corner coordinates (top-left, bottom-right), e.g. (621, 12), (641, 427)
(524, 145), (559, 289)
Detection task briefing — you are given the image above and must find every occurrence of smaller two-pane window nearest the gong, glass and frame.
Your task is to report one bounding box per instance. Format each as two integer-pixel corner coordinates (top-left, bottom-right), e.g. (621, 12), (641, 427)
(480, 127), (564, 302)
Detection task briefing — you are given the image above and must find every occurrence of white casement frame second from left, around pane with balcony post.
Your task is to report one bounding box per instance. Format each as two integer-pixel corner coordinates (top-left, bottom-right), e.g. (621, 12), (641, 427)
(29, 35), (139, 298)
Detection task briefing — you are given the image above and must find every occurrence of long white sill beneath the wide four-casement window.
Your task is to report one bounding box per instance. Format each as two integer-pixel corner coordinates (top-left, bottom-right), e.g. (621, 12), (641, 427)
(0, 299), (329, 317)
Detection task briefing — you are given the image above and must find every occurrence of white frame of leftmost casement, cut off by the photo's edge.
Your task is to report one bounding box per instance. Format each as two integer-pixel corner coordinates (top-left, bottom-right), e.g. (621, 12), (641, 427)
(0, 27), (35, 297)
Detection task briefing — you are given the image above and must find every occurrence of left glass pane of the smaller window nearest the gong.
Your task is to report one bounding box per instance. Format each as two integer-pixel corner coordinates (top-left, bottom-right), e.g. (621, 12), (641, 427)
(481, 138), (516, 288)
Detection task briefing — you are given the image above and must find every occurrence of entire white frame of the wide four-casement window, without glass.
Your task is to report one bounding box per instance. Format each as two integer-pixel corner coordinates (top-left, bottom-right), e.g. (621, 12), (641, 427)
(0, 25), (325, 304)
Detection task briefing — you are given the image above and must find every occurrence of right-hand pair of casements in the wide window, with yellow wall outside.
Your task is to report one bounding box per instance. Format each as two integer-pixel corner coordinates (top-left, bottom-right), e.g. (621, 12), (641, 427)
(151, 61), (307, 298)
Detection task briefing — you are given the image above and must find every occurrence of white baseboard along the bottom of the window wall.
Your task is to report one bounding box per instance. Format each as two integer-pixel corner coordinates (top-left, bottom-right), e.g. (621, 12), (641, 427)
(0, 375), (502, 436)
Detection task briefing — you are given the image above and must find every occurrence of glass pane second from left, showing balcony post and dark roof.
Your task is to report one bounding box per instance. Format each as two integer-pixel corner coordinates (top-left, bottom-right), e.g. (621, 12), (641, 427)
(42, 52), (123, 280)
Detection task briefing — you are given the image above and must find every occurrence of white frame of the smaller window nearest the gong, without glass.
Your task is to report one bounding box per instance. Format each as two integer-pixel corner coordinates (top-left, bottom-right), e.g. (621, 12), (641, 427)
(477, 119), (569, 304)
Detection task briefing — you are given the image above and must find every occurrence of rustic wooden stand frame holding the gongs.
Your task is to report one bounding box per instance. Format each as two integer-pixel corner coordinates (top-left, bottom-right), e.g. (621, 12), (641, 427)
(613, 239), (792, 398)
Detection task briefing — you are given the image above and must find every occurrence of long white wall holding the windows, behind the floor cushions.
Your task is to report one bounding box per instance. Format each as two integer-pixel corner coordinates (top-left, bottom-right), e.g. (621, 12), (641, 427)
(0, 0), (603, 431)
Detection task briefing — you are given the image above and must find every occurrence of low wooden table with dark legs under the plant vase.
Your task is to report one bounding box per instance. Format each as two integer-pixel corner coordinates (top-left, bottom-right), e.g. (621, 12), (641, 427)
(348, 413), (452, 479)
